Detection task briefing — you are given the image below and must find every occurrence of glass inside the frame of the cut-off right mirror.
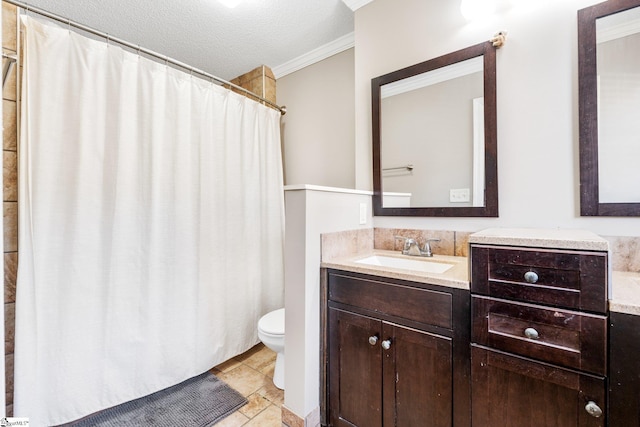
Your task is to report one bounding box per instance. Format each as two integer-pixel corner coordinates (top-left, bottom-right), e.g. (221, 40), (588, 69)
(596, 7), (640, 203)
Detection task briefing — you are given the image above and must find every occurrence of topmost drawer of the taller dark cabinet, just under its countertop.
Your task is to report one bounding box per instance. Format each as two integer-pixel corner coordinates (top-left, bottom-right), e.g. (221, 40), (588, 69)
(471, 245), (607, 314)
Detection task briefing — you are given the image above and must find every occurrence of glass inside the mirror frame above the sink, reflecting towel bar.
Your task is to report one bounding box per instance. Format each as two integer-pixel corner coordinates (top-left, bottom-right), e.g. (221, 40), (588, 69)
(381, 57), (484, 207)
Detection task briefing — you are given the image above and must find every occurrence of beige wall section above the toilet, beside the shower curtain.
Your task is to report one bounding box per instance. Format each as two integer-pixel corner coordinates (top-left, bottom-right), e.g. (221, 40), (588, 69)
(277, 49), (355, 188)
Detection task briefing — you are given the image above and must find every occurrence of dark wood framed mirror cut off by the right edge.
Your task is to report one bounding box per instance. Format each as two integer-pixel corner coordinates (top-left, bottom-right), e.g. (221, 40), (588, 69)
(578, 0), (640, 216)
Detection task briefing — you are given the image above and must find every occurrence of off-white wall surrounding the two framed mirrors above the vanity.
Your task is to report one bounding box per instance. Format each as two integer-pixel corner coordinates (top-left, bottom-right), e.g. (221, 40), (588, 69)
(355, 0), (640, 236)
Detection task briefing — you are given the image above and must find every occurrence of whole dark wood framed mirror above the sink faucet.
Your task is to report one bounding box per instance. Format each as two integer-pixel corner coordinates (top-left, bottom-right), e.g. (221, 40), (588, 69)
(371, 42), (498, 217)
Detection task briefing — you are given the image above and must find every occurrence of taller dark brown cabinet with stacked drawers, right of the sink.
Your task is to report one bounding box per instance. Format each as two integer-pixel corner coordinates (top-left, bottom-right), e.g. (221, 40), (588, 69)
(471, 244), (607, 427)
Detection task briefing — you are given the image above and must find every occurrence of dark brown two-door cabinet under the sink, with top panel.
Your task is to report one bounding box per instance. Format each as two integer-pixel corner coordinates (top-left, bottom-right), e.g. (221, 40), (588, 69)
(323, 270), (470, 427)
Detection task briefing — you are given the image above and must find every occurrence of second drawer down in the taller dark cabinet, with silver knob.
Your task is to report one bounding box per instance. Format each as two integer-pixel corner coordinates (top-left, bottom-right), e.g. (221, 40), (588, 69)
(471, 296), (607, 375)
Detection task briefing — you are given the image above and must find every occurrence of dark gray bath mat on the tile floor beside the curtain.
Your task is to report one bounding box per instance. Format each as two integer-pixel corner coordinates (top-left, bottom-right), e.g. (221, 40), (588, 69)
(65, 372), (247, 427)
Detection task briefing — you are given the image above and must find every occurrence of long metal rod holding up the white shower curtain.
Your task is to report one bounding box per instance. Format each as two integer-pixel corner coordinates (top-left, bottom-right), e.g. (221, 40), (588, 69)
(2, 0), (287, 116)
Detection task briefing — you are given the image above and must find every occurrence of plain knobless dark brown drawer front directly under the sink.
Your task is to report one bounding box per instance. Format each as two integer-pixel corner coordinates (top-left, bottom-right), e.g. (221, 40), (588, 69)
(328, 271), (453, 329)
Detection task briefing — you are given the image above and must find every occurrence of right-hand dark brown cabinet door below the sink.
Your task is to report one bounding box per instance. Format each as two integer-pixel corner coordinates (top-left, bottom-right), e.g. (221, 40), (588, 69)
(382, 323), (453, 427)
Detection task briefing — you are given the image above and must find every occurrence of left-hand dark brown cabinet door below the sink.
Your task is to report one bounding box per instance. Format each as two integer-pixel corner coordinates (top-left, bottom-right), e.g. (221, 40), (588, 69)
(329, 308), (382, 427)
